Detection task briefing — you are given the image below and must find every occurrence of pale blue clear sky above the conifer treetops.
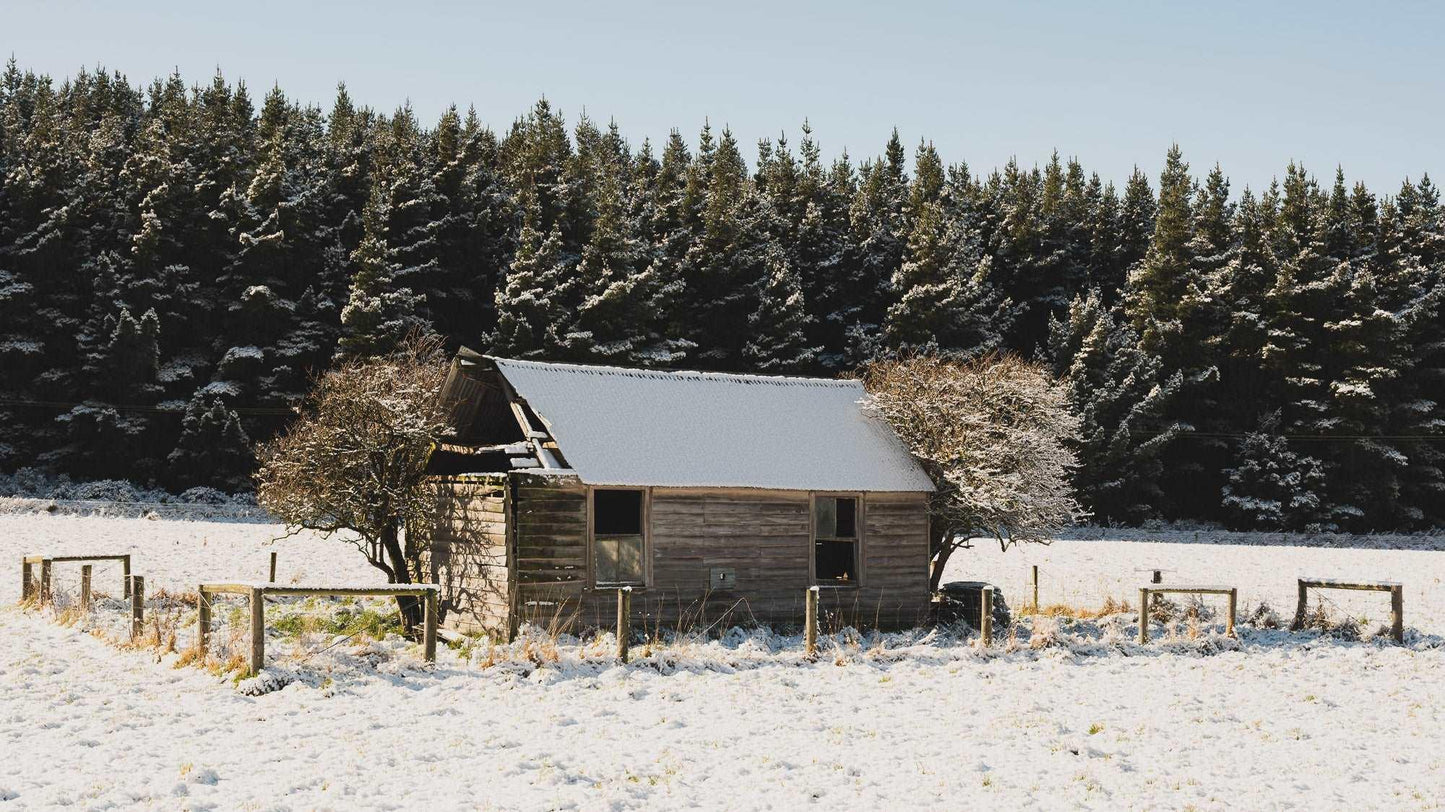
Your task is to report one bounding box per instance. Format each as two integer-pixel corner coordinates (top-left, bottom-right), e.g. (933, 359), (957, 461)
(0, 0), (1445, 192)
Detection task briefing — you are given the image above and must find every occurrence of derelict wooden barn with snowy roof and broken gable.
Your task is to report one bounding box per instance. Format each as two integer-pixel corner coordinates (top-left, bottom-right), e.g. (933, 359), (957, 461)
(409, 350), (933, 636)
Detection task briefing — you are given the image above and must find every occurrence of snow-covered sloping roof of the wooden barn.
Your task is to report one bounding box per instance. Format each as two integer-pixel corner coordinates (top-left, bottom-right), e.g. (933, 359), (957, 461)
(491, 358), (933, 491)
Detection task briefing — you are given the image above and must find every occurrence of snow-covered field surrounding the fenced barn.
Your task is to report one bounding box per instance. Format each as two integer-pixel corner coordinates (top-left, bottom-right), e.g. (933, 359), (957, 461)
(0, 516), (1445, 811)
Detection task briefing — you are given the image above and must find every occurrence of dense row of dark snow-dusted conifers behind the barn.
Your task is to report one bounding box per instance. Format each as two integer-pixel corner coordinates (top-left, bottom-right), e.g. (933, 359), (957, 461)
(0, 61), (1445, 530)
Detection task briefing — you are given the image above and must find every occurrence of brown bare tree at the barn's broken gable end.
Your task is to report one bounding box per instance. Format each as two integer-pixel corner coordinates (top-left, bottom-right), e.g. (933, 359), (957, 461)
(256, 335), (448, 629)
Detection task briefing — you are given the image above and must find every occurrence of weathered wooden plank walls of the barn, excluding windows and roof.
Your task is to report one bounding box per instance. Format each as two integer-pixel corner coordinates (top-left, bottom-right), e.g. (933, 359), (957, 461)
(421, 474), (929, 634)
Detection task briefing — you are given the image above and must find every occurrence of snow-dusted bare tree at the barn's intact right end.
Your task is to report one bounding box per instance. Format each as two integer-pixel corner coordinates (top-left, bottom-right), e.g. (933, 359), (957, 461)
(863, 355), (1085, 589)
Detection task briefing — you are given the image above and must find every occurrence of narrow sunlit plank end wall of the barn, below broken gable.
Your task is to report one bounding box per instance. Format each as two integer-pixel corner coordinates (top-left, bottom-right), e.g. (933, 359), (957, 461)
(409, 477), (516, 636)
